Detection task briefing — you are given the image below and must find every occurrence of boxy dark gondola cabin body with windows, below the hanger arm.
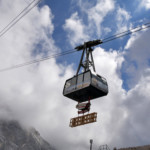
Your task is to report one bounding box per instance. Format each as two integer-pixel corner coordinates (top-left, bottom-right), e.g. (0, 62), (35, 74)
(63, 70), (108, 102)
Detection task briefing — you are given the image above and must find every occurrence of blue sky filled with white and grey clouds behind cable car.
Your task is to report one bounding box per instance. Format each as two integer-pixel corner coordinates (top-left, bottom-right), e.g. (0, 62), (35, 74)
(0, 0), (150, 150)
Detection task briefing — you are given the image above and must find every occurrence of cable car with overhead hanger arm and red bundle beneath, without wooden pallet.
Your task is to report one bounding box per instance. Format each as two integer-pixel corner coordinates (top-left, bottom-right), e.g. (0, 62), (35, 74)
(63, 40), (108, 114)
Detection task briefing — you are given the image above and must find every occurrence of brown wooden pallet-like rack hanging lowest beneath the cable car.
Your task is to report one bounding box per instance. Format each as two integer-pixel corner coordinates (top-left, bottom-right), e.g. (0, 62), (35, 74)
(70, 112), (97, 127)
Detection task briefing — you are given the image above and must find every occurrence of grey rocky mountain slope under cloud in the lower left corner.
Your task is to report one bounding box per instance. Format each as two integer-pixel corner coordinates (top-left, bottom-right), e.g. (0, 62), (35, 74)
(0, 120), (54, 150)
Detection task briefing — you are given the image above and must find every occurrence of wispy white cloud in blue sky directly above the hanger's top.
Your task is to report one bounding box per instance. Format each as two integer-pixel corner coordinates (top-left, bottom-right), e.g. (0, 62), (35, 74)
(63, 0), (115, 46)
